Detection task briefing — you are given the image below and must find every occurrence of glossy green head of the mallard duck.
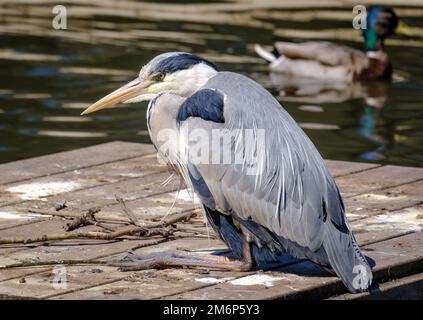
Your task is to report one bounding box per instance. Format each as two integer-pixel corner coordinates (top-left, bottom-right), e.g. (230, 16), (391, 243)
(363, 7), (398, 51)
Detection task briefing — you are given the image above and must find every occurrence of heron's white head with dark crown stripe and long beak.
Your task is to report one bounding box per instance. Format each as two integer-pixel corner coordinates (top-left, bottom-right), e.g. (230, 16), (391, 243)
(82, 52), (217, 115)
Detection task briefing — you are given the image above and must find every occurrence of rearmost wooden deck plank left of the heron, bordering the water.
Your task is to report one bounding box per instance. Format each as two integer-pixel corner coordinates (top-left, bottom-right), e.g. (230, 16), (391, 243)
(0, 141), (155, 185)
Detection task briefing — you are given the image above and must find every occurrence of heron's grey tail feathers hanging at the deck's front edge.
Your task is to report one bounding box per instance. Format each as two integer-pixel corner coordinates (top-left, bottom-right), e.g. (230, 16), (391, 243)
(323, 221), (373, 293)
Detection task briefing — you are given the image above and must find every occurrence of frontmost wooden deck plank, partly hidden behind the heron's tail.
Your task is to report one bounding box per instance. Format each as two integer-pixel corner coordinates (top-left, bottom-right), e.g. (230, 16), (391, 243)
(167, 232), (423, 300)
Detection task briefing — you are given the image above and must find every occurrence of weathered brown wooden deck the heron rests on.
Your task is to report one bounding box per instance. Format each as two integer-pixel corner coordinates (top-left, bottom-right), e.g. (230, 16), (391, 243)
(0, 142), (423, 299)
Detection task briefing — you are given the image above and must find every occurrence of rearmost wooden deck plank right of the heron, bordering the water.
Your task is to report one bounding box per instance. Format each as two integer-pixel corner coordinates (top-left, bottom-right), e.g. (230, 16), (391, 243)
(336, 166), (423, 197)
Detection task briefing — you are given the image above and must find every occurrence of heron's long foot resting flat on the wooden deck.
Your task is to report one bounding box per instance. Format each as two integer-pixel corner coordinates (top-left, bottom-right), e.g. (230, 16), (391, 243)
(108, 250), (253, 271)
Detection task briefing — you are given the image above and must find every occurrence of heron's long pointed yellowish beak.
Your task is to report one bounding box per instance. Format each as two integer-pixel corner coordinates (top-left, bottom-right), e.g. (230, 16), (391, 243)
(81, 78), (152, 116)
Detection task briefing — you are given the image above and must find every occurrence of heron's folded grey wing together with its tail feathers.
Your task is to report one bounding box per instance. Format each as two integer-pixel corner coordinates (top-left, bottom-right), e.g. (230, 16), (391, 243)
(183, 72), (371, 291)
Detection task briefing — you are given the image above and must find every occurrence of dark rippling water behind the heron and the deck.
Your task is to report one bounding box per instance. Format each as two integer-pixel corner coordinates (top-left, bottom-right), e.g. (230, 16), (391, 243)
(0, 1), (423, 166)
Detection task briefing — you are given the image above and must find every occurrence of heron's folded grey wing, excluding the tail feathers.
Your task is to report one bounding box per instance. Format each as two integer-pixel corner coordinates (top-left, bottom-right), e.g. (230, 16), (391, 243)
(182, 73), (345, 250)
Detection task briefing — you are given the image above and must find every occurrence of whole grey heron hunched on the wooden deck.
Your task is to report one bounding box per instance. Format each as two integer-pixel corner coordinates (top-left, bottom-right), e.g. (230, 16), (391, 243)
(82, 52), (372, 292)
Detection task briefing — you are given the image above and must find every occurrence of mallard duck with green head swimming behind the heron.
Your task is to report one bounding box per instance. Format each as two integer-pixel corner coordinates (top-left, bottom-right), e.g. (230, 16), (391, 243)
(255, 7), (409, 81)
